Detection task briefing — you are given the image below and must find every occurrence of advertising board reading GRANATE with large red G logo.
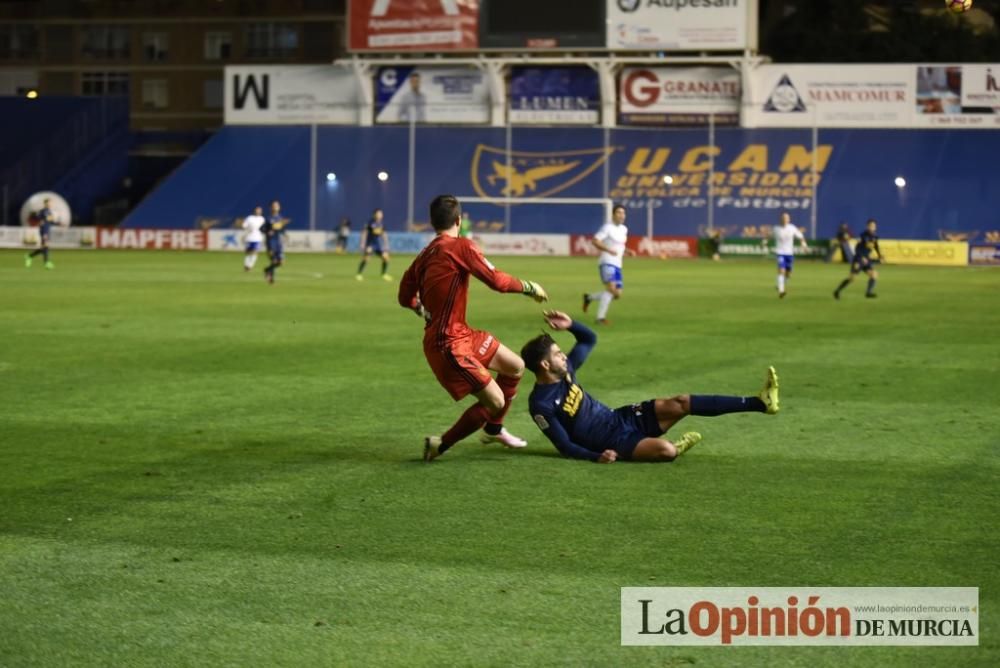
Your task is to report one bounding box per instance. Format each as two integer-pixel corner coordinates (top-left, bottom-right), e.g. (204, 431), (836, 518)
(618, 67), (740, 125)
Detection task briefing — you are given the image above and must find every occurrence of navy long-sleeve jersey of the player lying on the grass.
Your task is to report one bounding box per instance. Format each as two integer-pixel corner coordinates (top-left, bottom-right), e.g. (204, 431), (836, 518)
(528, 321), (623, 461)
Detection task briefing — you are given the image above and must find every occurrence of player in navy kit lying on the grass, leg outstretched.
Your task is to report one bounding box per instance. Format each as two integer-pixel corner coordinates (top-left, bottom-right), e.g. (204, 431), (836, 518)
(521, 311), (778, 464)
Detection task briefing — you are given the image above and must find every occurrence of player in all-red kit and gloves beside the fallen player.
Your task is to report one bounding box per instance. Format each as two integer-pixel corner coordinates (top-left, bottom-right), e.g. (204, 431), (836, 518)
(399, 195), (549, 462)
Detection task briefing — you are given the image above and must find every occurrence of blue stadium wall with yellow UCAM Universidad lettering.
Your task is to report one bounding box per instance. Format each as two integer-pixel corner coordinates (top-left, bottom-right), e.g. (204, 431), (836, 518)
(124, 127), (1000, 239)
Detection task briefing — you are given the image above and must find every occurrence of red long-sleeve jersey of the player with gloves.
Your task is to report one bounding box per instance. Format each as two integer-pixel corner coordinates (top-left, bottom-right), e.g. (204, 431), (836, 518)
(399, 234), (523, 350)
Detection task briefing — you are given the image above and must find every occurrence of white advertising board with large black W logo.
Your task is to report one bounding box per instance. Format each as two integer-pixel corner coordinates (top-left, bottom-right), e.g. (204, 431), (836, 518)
(223, 65), (361, 125)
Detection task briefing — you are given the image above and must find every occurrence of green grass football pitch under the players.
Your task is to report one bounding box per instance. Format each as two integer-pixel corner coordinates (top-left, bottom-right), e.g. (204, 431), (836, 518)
(0, 251), (1000, 667)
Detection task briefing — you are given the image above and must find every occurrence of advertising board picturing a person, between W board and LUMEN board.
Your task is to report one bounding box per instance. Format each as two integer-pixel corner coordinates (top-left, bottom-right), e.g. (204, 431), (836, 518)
(375, 66), (490, 123)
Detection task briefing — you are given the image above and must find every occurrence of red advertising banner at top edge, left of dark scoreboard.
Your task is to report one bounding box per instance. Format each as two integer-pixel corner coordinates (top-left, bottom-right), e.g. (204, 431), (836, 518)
(347, 0), (479, 51)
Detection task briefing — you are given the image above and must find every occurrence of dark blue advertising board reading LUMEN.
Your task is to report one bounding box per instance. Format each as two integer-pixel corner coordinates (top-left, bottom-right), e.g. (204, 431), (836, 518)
(509, 67), (601, 125)
